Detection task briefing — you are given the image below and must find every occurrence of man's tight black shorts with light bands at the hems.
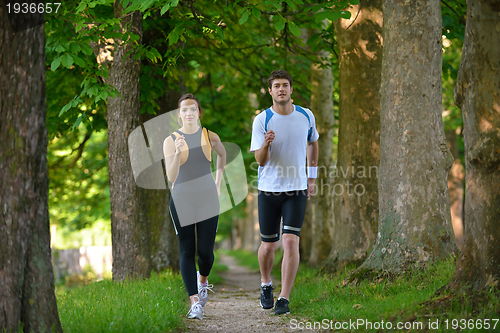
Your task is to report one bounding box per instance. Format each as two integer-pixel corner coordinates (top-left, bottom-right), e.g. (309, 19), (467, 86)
(258, 190), (307, 242)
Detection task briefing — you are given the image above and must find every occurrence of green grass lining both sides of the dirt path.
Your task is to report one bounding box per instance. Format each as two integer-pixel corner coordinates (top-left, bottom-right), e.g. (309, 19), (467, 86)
(56, 251), (500, 333)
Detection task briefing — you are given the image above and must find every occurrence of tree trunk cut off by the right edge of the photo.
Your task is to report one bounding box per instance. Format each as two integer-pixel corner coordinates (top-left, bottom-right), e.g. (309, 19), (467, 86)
(451, 0), (500, 290)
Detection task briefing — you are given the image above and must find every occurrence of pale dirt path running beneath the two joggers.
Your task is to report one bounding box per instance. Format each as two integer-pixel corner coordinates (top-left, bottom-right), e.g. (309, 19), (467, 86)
(186, 255), (314, 333)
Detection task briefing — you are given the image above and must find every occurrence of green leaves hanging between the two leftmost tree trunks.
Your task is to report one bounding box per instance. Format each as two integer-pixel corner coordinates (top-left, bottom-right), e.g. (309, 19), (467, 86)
(45, 2), (113, 132)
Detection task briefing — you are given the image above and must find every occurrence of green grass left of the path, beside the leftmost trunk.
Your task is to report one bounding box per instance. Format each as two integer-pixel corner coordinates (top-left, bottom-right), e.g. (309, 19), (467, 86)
(56, 272), (188, 333)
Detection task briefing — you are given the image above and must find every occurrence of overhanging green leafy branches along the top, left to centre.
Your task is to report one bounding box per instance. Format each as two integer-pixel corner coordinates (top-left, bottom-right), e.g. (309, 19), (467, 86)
(45, 0), (359, 128)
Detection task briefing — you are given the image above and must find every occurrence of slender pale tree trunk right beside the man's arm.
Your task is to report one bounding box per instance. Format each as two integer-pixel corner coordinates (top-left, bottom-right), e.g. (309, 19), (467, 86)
(307, 33), (334, 266)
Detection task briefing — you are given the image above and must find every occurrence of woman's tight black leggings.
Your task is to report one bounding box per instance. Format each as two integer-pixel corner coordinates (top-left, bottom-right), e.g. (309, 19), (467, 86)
(170, 193), (219, 296)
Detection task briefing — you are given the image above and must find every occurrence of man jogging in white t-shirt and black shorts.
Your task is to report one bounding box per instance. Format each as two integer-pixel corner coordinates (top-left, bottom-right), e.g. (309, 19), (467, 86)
(250, 70), (319, 314)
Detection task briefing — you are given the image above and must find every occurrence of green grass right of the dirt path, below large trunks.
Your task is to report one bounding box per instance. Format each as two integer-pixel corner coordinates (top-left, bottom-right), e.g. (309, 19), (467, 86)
(228, 251), (500, 332)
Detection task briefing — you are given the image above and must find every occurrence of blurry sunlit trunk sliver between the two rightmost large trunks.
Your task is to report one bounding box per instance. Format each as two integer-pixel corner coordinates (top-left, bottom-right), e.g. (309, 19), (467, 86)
(446, 130), (465, 250)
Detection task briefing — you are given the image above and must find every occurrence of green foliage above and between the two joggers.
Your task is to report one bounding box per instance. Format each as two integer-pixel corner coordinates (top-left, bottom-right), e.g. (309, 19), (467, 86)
(141, 3), (344, 237)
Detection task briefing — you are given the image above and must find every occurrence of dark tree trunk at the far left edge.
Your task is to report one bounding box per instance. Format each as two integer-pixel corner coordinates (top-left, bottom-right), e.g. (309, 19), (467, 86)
(0, 6), (62, 332)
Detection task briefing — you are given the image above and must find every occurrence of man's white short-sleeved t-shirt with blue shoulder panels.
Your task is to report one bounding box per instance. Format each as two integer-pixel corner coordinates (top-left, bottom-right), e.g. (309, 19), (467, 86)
(250, 105), (319, 192)
